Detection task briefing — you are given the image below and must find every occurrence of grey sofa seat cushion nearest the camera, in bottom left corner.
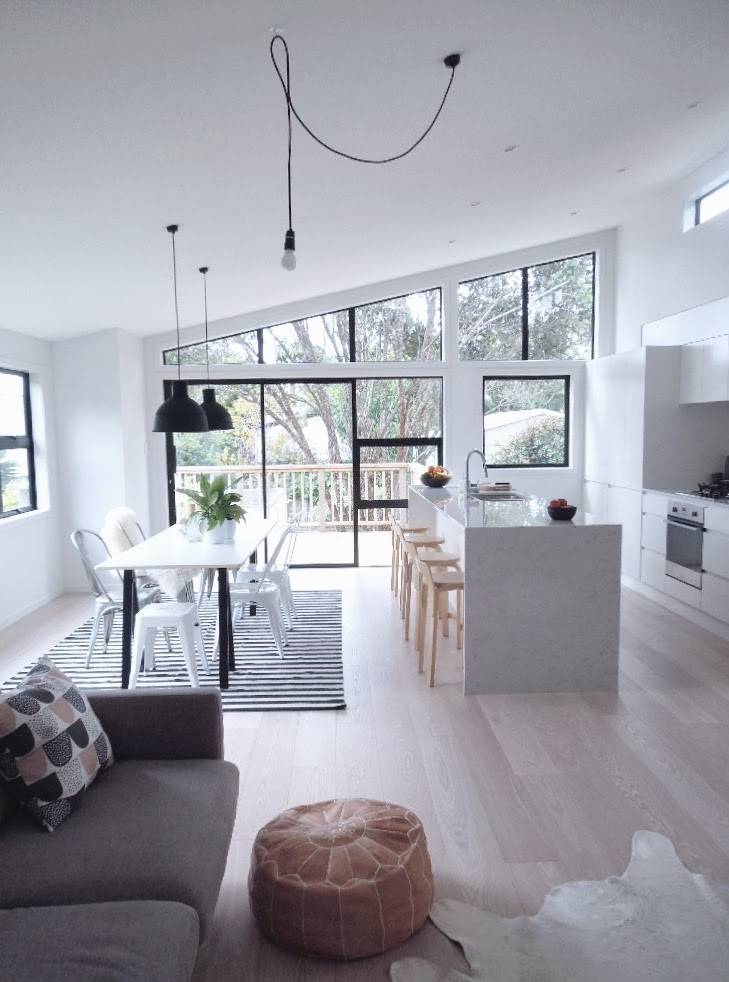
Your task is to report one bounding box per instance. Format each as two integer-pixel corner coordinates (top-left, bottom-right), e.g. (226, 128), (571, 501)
(0, 900), (199, 982)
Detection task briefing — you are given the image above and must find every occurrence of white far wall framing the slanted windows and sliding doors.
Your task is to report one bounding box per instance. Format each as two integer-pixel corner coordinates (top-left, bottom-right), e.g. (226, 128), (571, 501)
(144, 230), (615, 530)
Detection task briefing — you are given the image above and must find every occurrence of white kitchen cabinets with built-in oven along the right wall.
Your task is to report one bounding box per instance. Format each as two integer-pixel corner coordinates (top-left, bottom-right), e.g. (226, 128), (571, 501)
(584, 299), (729, 639)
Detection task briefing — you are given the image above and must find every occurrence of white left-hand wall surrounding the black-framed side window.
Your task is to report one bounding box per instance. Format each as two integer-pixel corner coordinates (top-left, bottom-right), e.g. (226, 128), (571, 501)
(0, 328), (63, 629)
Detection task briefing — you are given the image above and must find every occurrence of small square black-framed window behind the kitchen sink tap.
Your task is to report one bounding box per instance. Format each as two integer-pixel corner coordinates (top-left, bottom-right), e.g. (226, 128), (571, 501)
(483, 375), (570, 467)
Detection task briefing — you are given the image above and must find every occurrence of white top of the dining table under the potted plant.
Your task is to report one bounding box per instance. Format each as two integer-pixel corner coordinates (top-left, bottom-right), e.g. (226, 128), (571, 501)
(96, 517), (278, 570)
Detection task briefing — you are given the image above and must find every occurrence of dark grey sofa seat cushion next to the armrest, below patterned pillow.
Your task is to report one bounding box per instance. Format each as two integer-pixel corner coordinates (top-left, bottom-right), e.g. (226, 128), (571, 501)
(0, 760), (238, 935)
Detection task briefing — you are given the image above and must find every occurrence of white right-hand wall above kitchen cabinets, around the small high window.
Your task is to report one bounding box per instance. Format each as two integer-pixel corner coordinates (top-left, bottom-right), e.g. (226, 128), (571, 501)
(615, 142), (729, 351)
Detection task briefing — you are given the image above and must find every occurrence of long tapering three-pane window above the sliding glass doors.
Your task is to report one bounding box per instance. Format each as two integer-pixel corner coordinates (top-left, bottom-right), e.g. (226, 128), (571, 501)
(163, 288), (442, 365)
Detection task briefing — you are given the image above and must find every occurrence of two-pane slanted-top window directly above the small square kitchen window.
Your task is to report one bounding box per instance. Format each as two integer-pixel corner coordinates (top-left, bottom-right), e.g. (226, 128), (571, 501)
(458, 253), (595, 361)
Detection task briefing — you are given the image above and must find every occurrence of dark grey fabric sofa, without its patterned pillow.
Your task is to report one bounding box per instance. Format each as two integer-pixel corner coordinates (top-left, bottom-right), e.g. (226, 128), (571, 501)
(0, 689), (238, 982)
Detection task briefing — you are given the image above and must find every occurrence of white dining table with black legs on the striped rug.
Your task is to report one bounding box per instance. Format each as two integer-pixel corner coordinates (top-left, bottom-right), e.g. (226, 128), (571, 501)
(96, 517), (279, 689)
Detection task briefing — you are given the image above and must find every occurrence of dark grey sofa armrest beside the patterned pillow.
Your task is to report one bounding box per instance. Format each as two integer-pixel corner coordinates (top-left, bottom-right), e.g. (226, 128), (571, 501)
(84, 689), (223, 760)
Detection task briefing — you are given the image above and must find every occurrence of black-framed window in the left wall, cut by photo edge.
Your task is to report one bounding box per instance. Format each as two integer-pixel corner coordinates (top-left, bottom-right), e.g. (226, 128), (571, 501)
(0, 368), (36, 519)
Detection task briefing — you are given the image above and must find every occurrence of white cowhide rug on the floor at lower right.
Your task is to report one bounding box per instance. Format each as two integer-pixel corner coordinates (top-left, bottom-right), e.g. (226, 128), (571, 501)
(390, 832), (729, 982)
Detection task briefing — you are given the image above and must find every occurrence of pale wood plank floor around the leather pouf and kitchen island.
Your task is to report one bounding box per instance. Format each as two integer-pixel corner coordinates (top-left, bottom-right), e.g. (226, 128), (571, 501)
(0, 569), (729, 982)
